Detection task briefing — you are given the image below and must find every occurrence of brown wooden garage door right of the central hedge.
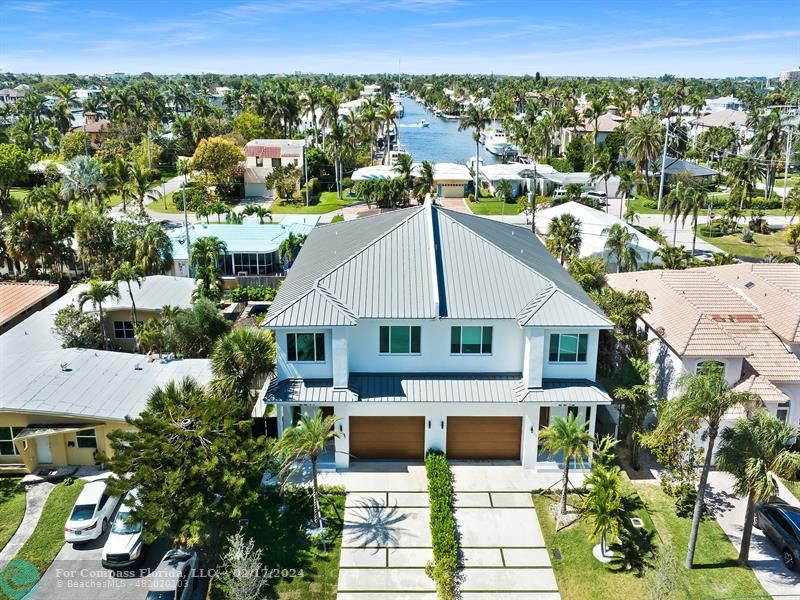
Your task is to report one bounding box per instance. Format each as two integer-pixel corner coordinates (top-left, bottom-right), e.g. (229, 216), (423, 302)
(447, 417), (522, 460)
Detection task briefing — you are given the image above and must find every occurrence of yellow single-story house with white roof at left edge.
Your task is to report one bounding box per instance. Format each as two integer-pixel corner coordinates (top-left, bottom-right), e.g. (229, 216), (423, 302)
(0, 276), (211, 473)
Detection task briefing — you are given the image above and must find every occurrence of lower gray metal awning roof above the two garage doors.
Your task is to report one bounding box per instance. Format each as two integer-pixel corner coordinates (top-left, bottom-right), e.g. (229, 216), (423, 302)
(264, 373), (611, 405)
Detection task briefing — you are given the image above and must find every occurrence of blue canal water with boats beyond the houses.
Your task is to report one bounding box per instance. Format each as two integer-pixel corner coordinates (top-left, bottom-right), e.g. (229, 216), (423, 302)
(398, 96), (502, 165)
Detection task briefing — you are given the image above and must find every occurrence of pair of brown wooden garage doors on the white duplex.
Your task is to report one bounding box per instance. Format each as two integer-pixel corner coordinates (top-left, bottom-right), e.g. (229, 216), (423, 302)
(349, 416), (522, 460)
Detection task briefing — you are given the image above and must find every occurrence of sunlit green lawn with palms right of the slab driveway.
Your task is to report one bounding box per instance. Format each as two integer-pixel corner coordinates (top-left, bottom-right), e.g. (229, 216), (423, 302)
(534, 476), (768, 600)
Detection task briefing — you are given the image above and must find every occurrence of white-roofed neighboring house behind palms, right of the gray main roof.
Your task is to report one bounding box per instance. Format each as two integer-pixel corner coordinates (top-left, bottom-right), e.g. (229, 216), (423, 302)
(536, 200), (660, 272)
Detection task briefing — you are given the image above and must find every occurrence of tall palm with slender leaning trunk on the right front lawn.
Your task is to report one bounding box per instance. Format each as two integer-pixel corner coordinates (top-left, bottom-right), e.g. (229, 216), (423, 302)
(655, 361), (760, 569)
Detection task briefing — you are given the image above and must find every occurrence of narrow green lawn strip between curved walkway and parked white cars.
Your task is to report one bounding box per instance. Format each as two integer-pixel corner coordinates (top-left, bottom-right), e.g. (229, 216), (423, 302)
(0, 480), (84, 598)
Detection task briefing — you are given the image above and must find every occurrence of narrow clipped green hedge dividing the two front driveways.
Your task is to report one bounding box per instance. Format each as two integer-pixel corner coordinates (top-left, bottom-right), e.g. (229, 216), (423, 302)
(425, 450), (458, 600)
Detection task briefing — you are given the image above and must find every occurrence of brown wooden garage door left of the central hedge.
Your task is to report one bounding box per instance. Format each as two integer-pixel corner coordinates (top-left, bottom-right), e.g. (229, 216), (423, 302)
(350, 417), (425, 459)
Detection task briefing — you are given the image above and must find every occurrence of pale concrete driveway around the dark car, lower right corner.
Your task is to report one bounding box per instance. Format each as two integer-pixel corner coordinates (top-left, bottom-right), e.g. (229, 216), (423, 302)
(706, 471), (800, 599)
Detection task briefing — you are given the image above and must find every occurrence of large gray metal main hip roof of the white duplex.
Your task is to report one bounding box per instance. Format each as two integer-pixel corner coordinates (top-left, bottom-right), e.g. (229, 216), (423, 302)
(264, 206), (611, 327)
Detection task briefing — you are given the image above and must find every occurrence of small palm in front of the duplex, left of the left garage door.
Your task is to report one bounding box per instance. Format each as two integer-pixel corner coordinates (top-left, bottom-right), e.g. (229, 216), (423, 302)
(274, 409), (342, 529)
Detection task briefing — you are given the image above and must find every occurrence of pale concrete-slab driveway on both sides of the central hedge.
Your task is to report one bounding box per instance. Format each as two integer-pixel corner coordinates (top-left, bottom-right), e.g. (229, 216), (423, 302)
(332, 464), (560, 600)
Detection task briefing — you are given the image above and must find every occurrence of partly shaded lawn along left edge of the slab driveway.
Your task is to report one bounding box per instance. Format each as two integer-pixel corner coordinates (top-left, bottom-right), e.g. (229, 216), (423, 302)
(213, 490), (344, 600)
